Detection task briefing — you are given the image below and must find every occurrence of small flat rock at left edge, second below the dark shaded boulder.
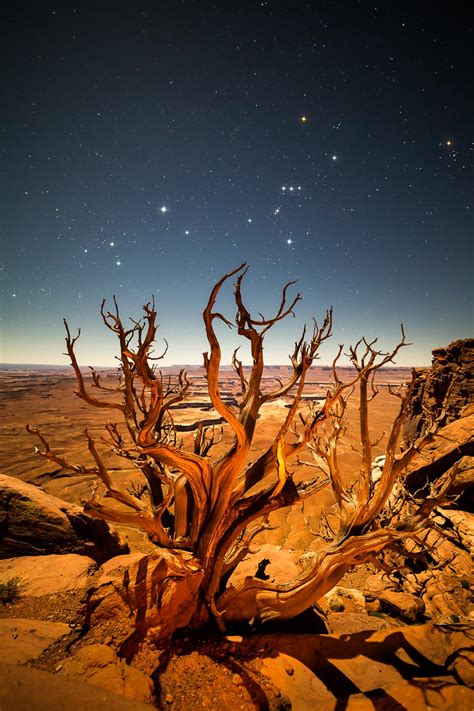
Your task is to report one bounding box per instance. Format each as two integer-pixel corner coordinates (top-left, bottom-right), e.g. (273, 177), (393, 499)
(0, 618), (71, 664)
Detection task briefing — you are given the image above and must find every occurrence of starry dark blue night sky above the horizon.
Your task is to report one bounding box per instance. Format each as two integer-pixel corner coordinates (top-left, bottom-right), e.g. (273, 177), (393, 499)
(0, 0), (474, 365)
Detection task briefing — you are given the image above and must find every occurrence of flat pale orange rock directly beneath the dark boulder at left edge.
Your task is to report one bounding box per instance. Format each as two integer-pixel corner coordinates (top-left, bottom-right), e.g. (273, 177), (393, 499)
(0, 553), (97, 597)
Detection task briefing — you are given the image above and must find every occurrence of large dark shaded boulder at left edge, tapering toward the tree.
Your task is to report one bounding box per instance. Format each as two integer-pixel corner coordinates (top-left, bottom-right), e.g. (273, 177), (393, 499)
(0, 475), (129, 564)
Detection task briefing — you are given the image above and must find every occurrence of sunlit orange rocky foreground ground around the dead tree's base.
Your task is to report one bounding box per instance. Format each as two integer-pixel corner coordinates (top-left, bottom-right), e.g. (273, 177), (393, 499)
(0, 492), (474, 711)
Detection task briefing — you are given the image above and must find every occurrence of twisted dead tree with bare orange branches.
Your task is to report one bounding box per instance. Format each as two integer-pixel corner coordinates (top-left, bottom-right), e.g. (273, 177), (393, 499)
(29, 264), (446, 629)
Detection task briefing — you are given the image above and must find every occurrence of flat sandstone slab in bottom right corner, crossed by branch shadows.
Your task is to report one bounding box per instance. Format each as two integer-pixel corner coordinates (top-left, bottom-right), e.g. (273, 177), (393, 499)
(256, 624), (474, 711)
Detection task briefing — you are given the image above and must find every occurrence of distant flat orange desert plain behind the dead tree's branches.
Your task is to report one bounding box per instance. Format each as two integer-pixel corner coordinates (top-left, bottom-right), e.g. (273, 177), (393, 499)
(0, 368), (410, 552)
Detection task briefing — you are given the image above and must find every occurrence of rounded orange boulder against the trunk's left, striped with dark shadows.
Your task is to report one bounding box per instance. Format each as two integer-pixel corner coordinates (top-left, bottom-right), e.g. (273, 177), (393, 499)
(90, 549), (203, 639)
